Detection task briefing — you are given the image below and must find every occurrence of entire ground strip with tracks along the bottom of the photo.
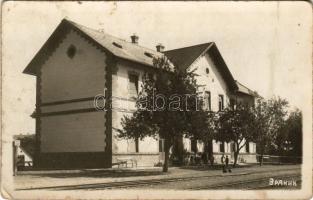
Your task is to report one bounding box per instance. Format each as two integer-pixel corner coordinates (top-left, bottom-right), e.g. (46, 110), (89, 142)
(14, 165), (301, 191)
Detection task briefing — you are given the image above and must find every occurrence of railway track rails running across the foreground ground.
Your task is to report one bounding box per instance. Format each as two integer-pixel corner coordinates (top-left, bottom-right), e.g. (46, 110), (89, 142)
(19, 169), (300, 190)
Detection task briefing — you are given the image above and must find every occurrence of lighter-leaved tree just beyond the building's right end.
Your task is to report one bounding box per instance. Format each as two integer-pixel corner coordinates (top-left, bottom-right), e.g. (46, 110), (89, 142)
(253, 97), (288, 165)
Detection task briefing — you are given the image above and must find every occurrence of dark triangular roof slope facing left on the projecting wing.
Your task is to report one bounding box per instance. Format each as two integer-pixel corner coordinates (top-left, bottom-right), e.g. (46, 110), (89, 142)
(164, 42), (213, 69)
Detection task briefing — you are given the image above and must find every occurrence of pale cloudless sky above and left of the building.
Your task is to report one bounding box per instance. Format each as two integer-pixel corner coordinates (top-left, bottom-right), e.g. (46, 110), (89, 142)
(2, 1), (312, 134)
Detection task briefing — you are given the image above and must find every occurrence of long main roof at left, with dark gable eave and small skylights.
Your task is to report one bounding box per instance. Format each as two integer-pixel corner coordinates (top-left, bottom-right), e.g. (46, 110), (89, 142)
(24, 19), (163, 75)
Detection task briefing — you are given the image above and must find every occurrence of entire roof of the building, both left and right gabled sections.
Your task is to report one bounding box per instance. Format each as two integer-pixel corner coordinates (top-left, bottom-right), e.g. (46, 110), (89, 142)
(24, 19), (238, 90)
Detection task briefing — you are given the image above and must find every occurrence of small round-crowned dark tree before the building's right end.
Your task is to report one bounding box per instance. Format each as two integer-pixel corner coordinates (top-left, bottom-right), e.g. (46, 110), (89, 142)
(215, 104), (254, 167)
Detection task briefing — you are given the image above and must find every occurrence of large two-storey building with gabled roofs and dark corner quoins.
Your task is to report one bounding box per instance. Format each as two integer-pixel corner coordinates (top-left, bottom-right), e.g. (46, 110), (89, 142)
(24, 19), (256, 168)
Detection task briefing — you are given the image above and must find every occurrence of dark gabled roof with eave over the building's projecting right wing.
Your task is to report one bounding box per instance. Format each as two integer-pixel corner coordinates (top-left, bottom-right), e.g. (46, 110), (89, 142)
(164, 42), (238, 91)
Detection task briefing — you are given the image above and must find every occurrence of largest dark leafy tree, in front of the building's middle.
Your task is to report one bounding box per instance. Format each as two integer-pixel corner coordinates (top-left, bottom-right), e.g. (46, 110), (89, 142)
(118, 57), (207, 172)
